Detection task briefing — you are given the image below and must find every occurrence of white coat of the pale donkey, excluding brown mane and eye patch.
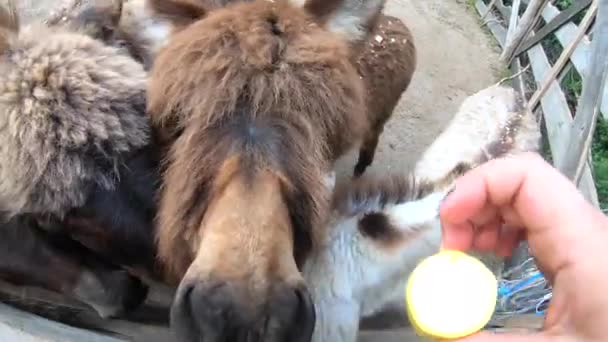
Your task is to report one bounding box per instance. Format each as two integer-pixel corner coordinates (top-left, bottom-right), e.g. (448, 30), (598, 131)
(303, 86), (540, 342)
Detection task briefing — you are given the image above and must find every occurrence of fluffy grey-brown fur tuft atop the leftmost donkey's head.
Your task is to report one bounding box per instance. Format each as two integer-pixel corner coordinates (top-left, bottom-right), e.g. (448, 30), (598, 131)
(0, 8), (149, 217)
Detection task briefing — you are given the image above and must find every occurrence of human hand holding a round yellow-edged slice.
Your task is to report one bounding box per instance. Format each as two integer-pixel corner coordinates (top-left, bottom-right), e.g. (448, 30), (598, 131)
(440, 153), (608, 342)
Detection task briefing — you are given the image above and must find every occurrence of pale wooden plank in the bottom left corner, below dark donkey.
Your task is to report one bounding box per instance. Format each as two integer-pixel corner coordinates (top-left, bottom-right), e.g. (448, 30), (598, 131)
(0, 303), (123, 342)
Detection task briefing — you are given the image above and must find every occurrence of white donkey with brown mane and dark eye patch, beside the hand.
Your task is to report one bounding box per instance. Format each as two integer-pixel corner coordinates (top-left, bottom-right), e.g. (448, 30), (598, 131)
(303, 86), (540, 342)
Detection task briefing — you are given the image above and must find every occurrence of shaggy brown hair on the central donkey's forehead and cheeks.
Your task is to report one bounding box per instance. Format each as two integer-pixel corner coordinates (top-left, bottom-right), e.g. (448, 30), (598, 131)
(149, 1), (366, 273)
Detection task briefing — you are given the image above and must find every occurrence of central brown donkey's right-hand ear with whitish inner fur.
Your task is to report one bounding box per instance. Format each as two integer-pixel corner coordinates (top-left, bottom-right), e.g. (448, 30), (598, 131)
(302, 0), (386, 43)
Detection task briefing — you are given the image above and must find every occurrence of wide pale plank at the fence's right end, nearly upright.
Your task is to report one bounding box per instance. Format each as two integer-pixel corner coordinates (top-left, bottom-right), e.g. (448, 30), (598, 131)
(558, 0), (608, 184)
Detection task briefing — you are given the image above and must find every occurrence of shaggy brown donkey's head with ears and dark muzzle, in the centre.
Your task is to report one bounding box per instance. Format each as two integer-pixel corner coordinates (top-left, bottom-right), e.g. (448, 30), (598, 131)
(148, 0), (384, 341)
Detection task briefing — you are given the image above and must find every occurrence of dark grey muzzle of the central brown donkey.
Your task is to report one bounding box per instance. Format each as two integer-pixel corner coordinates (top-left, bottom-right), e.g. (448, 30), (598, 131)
(171, 282), (315, 342)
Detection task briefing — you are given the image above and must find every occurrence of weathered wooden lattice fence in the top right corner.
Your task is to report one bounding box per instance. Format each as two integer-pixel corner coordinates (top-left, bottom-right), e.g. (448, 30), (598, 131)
(475, 0), (608, 207)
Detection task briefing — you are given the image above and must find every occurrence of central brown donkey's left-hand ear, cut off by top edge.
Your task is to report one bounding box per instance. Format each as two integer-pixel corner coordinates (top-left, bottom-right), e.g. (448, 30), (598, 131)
(147, 0), (207, 27)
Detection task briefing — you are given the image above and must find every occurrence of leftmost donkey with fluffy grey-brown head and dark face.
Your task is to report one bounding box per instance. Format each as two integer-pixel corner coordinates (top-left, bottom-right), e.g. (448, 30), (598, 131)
(0, 3), (159, 317)
